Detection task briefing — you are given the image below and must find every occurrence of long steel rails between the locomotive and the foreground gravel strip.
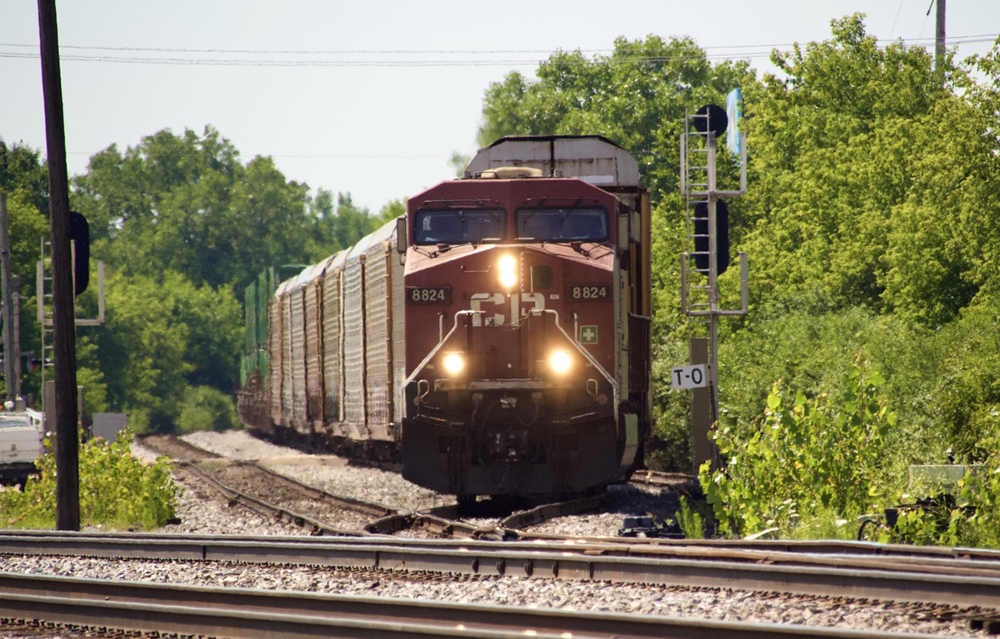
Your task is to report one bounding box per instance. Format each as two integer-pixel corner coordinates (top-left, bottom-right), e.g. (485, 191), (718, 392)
(0, 535), (1000, 609)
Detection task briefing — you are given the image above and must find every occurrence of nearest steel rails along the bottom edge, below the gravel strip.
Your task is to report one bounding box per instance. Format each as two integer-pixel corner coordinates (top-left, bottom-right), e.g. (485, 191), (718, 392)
(0, 573), (944, 639)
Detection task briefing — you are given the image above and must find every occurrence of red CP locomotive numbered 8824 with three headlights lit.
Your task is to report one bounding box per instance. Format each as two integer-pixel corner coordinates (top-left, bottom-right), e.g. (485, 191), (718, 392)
(400, 136), (651, 495)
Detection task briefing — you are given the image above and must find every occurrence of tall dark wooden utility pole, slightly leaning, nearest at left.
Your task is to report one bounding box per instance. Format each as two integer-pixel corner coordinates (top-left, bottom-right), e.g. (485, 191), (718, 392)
(38, 0), (80, 530)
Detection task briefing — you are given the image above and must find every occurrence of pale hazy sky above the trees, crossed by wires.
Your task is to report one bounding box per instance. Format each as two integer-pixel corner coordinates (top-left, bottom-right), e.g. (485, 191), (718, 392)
(0, 0), (1000, 212)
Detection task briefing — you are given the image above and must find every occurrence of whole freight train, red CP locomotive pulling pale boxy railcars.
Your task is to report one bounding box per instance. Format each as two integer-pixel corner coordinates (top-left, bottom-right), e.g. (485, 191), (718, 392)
(238, 136), (651, 500)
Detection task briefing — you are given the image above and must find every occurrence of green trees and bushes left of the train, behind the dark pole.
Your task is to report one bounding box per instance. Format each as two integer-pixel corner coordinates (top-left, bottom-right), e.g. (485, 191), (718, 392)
(0, 127), (394, 433)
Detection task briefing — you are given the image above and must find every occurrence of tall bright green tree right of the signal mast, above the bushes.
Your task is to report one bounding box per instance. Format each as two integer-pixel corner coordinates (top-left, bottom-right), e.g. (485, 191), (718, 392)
(745, 15), (1000, 326)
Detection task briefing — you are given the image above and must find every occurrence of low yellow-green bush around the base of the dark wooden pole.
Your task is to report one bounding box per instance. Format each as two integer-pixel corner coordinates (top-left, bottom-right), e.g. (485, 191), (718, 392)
(0, 431), (179, 530)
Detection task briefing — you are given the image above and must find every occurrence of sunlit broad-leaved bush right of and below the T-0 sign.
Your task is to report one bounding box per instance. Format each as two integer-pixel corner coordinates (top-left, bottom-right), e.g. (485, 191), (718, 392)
(699, 363), (896, 536)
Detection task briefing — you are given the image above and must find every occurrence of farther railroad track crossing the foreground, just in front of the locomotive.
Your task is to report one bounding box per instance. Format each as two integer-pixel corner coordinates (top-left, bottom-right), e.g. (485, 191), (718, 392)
(0, 531), (1000, 620)
